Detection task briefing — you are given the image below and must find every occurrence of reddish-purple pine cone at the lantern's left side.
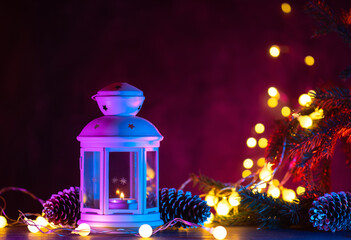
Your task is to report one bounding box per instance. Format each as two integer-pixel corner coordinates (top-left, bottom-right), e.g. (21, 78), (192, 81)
(43, 187), (80, 226)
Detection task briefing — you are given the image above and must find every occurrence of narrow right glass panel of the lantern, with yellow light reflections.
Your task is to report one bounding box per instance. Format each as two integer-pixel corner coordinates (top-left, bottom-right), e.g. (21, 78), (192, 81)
(146, 151), (157, 208)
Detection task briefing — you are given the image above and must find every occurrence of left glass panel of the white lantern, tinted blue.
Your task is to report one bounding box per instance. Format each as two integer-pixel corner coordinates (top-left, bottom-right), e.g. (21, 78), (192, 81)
(83, 152), (100, 209)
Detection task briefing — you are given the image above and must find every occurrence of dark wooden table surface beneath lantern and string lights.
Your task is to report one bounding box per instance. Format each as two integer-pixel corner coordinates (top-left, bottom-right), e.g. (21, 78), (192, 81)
(0, 227), (351, 240)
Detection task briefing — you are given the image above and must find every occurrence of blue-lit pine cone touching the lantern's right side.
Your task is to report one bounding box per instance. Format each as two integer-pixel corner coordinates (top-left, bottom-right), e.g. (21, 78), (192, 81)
(160, 188), (211, 228)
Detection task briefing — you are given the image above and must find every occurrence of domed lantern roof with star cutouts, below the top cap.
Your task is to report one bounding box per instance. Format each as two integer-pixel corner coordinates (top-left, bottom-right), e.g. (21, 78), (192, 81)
(77, 116), (163, 141)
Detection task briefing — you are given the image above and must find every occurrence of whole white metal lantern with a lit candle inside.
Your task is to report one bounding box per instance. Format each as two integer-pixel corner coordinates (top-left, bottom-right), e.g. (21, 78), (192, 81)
(77, 83), (163, 227)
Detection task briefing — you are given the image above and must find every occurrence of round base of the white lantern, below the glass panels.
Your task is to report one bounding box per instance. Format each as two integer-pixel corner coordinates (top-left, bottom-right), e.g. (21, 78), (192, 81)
(78, 213), (163, 228)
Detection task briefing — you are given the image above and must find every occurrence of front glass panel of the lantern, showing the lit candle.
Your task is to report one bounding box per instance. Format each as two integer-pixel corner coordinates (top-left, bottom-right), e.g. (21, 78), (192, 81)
(109, 152), (138, 209)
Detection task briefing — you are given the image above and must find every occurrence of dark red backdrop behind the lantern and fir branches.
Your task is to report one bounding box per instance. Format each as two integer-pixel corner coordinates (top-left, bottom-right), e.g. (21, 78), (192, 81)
(0, 0), (351, 214)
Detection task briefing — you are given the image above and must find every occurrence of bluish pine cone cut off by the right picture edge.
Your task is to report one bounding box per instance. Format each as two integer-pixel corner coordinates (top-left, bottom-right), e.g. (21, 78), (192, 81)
(309, 192), (351, 232)
